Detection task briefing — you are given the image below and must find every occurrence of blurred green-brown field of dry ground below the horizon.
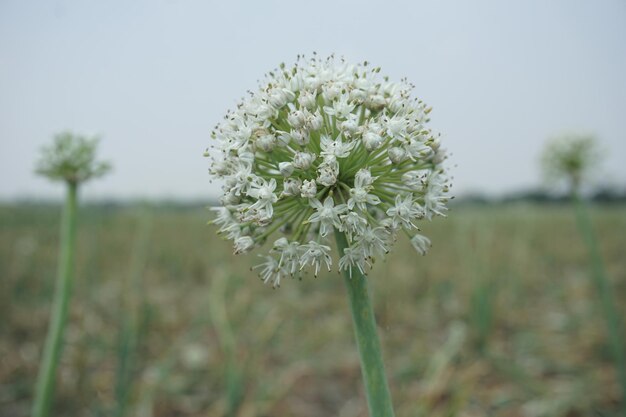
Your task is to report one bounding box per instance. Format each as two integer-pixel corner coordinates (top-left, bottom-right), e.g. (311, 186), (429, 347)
(0, 201), (626, 417)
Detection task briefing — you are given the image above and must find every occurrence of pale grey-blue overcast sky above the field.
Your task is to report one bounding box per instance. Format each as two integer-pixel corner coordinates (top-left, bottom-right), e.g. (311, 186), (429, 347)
(0, 0), (626, 200)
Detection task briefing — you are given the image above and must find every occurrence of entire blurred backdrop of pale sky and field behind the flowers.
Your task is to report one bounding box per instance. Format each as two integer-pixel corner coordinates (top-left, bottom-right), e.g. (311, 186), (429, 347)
(0, 0), (626, 417)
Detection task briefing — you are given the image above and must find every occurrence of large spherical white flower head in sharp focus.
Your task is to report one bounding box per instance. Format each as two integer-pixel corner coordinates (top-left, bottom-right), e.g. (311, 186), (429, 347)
(205, 56), (449, 286)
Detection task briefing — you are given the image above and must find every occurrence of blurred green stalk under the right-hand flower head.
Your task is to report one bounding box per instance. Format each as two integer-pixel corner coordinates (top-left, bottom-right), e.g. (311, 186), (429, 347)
(574, 193), (626, 416)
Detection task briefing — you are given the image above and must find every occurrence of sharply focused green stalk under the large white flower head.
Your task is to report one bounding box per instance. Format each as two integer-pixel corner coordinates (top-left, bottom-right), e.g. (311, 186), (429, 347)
(335, 231), (394, 417)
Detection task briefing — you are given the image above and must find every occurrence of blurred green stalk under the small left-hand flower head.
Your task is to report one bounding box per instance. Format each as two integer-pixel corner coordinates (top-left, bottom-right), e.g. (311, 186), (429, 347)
(32, 182), (78, 417)
